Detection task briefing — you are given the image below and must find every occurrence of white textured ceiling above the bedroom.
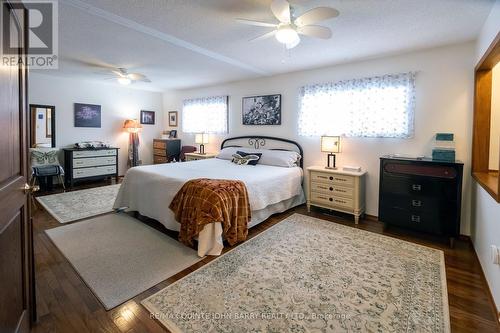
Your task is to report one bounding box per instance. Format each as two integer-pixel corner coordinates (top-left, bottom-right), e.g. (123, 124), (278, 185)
(37, 0), (494, 91)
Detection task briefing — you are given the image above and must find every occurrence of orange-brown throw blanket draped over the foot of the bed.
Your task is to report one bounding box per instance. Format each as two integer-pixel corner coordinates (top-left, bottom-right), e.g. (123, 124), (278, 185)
(169, 178), (251, 246)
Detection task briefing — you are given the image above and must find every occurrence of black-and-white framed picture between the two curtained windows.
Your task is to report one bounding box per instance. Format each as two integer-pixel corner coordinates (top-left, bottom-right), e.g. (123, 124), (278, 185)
(242, 95), (281, 125)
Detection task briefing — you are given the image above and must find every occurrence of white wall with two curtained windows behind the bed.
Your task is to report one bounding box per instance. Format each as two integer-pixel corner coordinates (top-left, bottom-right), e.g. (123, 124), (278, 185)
(163, 43), (474, 234)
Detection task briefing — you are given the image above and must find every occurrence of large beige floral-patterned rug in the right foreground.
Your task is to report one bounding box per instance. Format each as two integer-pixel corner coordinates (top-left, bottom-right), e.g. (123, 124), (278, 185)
(142, 214), (450, 332)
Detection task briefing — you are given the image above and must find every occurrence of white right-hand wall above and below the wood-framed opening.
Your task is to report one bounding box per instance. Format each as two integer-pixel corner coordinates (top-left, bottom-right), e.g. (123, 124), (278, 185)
(471, 0), (500, 312)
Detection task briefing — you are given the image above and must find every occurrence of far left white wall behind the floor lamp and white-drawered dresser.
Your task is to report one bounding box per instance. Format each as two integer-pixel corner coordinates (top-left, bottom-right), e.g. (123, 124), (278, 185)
(29, 73), (163, 175)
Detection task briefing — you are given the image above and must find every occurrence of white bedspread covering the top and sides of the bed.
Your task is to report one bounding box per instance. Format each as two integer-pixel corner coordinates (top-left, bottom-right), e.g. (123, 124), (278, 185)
(114, 158), (304, 254)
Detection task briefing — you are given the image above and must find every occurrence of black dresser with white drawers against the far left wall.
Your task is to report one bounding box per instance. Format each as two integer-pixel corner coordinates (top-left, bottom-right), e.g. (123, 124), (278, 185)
(64, 148), (118, 186)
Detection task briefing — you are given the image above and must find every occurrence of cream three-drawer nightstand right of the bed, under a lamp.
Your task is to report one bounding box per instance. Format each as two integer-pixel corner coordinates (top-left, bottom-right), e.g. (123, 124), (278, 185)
(307, 166), (366, 224)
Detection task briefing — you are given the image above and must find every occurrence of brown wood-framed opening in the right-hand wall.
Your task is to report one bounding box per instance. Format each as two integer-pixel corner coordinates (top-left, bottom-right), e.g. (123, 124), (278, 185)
(472, 34), (500, 202)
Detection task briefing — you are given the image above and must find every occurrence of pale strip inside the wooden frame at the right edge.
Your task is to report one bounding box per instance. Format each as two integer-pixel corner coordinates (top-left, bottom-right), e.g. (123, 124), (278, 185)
(490, 63), (500, 170)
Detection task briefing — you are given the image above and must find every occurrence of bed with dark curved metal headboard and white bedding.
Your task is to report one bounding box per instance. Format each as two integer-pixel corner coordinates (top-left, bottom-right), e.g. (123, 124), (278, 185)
(114, 136), (305, 256)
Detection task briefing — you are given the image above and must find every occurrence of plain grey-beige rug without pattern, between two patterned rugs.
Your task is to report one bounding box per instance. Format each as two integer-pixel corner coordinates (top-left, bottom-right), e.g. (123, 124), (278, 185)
(46, 213), (202, 310)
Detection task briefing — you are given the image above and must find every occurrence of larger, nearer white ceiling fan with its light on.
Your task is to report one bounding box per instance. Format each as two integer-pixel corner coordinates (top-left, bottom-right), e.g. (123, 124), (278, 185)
(236, 0), (339, 49)
